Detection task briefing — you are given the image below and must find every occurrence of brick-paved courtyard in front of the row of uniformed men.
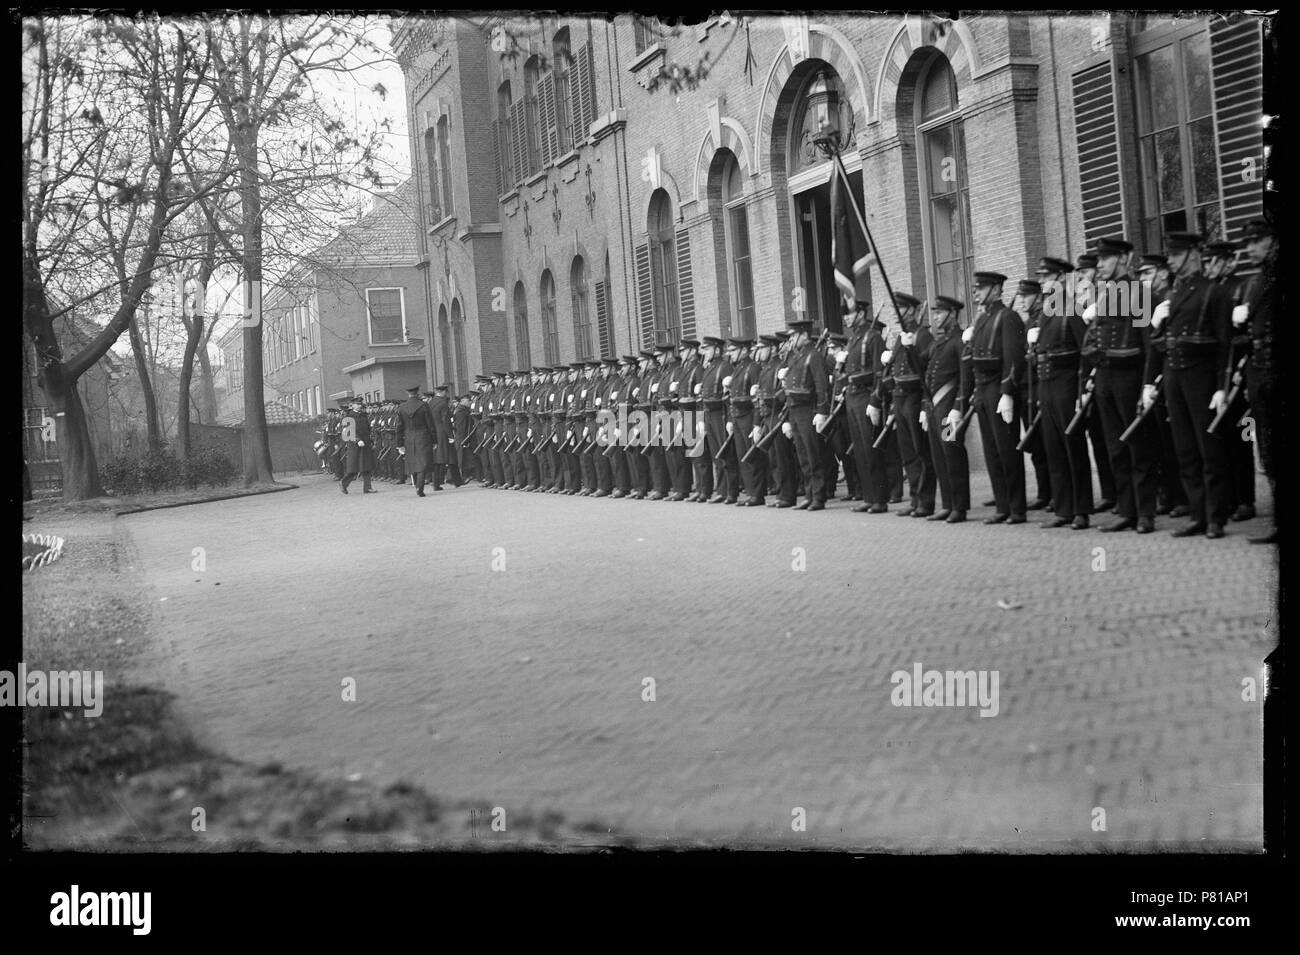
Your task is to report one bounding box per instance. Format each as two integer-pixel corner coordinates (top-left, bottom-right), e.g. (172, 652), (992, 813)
(118, 467), (1275, 851)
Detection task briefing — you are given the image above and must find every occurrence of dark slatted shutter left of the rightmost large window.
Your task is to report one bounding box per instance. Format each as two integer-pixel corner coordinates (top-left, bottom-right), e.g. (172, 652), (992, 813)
(1073, 60), (1125, 248)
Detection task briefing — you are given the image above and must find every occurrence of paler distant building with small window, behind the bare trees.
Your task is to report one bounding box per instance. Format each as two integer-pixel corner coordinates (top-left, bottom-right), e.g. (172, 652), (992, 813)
(218, 183), (432, 422)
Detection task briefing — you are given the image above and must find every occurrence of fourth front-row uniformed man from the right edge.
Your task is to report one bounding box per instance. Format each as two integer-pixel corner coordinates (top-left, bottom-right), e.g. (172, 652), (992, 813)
(1026, 272), (1093, 530)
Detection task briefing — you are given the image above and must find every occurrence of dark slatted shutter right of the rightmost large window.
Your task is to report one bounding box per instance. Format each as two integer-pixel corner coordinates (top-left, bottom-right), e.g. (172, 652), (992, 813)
(1210, 17), (1265, 239)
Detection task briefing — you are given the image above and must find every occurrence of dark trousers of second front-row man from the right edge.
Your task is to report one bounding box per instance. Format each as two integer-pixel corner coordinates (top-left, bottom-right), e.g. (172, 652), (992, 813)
(1165, 361), (1229, 524)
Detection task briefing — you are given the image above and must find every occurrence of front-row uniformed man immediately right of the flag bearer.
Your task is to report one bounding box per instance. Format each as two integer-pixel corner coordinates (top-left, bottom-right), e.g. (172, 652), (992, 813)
(920, 295), (974, 524)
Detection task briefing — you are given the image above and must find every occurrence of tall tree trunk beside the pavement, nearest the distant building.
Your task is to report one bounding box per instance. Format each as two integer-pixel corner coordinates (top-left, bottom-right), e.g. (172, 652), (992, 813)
(239, 136), (276, 485)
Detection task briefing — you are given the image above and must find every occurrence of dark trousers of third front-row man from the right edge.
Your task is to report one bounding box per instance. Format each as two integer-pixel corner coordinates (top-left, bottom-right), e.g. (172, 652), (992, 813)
(1097, 365), (1160, 520)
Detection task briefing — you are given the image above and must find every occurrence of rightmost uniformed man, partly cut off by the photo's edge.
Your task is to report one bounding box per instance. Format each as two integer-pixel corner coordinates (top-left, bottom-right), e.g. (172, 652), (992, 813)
(1229, 218), (1282, 544)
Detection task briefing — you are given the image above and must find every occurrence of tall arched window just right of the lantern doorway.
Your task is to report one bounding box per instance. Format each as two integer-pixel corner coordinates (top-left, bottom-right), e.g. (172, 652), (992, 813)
(915, 55), (975, 300)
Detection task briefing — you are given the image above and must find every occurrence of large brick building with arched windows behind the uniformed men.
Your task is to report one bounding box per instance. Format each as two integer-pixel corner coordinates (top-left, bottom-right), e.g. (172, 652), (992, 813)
(394, 13), (1264, 374)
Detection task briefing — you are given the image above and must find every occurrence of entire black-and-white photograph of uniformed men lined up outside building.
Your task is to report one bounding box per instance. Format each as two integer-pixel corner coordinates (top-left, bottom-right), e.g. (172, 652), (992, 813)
(15, 8), (1286, 938)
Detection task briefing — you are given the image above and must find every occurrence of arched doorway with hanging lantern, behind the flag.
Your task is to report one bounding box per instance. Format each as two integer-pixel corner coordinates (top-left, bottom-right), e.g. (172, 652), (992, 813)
(771, 60), (871, 331)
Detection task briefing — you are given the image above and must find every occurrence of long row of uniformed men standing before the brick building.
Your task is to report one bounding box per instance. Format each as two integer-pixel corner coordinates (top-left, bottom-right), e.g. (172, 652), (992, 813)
(319, 220), (1278, 543)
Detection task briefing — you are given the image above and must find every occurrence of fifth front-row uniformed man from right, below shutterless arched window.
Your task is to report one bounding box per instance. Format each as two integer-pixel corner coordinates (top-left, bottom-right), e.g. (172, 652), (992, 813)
(963, 272), (1027, 524)
